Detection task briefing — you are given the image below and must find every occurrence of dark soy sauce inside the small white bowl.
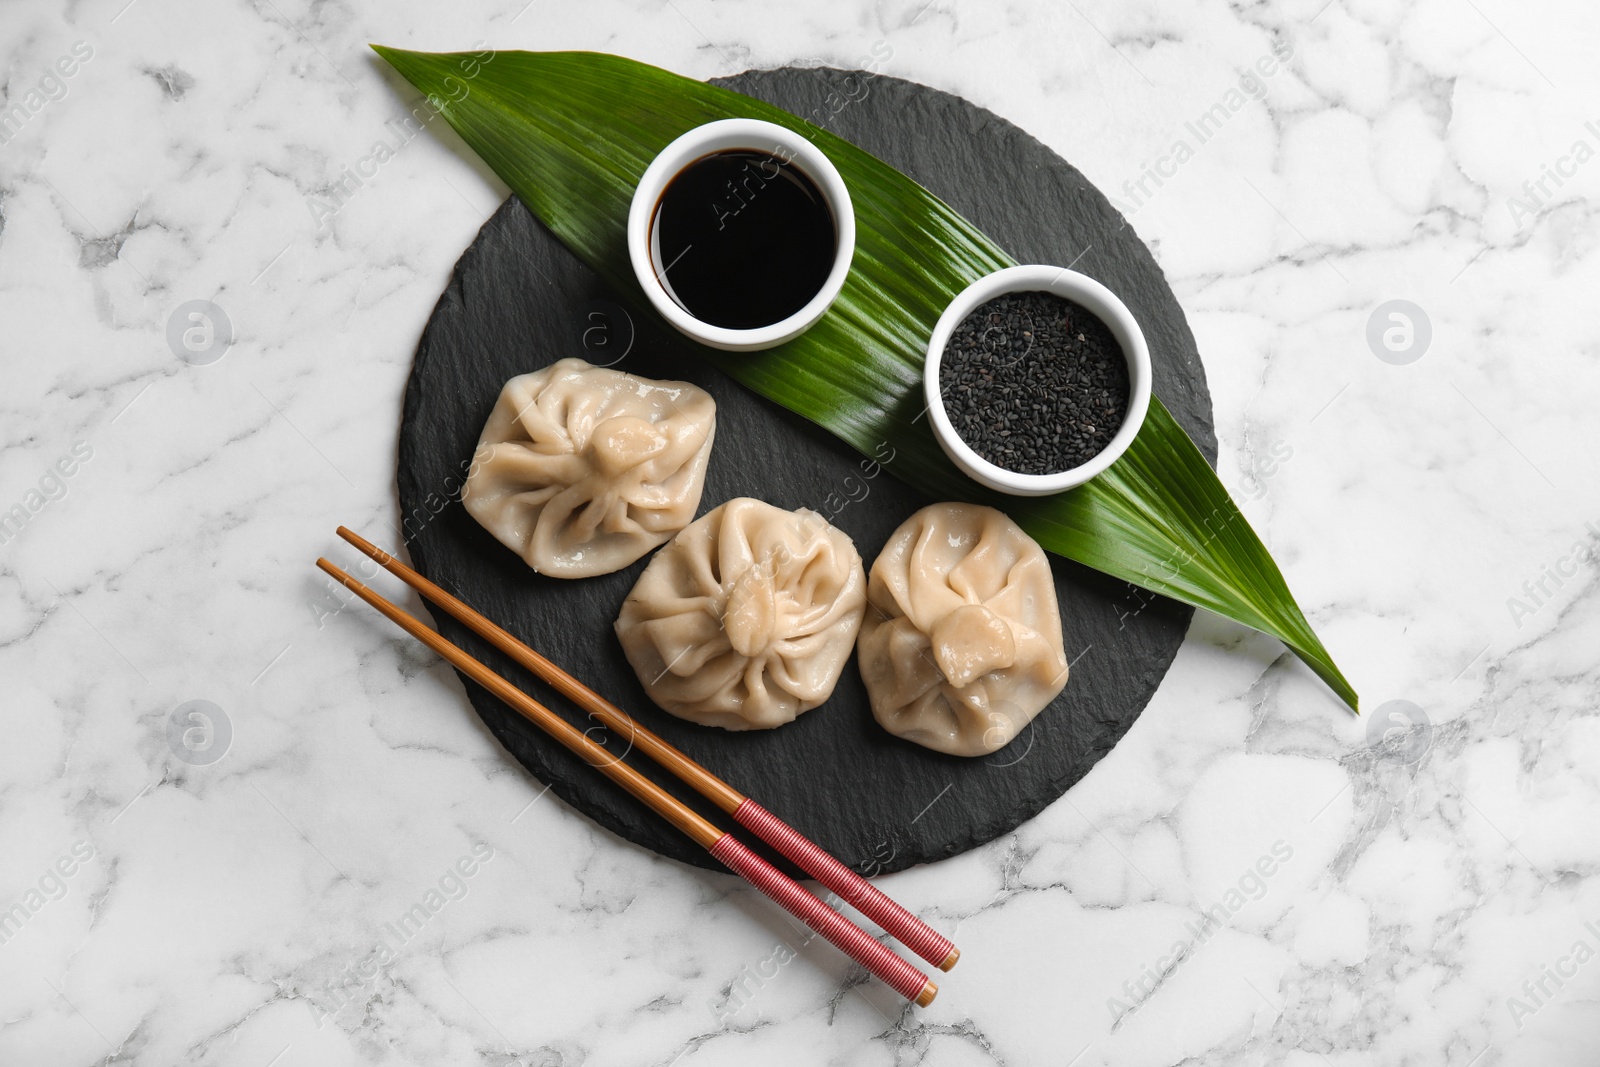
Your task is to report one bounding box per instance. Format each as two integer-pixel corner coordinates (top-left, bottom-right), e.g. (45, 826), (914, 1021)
(651, 149), (838, 330)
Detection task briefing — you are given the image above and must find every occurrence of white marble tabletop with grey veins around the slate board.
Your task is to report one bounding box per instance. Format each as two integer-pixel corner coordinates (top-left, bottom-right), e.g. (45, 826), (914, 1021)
(0, 0), (1600, 1067)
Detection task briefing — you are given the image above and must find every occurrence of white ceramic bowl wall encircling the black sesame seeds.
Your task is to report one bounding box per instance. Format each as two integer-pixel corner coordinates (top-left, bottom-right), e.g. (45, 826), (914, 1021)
(923, 264), (1150, 496)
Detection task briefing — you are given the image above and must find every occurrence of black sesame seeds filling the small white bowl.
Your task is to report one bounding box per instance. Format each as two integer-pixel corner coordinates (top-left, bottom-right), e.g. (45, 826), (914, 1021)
(939, 293), (1128, 474)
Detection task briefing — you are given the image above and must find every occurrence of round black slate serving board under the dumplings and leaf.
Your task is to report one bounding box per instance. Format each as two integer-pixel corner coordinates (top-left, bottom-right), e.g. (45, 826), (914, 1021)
(398, 69), (1216, 872)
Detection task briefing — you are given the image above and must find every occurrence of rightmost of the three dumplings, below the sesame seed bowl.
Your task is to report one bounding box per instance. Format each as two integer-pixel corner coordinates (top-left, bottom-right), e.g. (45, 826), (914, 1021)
(859, 504), (1067, 755)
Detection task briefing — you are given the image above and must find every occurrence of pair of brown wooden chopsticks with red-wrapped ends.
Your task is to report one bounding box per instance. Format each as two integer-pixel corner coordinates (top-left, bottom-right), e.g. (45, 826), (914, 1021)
(317, 526), (960, 1008)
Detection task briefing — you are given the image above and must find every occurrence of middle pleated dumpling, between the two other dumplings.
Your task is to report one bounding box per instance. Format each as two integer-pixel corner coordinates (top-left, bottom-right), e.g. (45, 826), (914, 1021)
(616, 498), (867, 729)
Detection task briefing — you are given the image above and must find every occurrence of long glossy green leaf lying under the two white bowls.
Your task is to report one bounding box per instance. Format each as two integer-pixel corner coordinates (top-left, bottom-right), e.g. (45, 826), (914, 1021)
(373, 45), (1357, 709)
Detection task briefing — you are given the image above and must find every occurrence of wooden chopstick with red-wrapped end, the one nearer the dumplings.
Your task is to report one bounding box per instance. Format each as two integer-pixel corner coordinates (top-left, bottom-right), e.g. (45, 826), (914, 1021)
(339, 526), (962, 971)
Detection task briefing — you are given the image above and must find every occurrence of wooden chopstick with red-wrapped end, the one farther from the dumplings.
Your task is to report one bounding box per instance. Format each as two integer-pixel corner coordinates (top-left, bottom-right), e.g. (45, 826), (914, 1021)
(317, 558), (939, 1008)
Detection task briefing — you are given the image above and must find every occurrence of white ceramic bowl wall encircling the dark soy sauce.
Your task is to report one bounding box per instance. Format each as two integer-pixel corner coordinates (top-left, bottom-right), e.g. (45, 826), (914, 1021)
(627, 118), (856, 352)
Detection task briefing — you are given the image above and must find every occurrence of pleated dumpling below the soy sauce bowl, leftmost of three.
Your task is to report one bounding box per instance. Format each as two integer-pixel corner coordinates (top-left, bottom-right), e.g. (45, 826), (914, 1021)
(461, 358), (717, 577)
